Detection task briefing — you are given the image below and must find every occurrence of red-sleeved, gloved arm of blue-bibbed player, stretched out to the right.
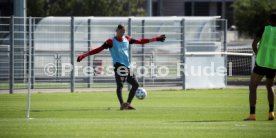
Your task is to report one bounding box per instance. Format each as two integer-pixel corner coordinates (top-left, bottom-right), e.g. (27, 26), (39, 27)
(127, 34), (166, 44)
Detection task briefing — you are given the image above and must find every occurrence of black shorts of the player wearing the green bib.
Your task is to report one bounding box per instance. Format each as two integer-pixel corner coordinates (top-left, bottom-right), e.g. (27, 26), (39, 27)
(253, 63), (276, 79)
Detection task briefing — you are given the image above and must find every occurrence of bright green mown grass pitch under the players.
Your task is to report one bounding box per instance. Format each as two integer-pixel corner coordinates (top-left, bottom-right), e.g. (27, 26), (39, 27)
(0, 89), (276, 138)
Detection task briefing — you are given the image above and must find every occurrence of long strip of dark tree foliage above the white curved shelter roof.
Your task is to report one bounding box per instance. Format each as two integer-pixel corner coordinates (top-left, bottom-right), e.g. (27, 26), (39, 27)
(27, 0), (145, 17)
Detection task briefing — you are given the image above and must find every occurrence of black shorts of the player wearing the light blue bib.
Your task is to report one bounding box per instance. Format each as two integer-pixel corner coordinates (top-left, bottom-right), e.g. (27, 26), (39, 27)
(114, 63), (139, 87)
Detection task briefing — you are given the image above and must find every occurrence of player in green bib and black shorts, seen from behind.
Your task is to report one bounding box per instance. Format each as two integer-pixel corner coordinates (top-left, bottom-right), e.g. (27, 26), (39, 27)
(244, 12), (276, 121)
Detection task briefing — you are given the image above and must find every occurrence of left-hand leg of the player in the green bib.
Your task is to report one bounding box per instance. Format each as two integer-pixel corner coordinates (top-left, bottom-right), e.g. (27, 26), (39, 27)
(244, 72), (263, 120)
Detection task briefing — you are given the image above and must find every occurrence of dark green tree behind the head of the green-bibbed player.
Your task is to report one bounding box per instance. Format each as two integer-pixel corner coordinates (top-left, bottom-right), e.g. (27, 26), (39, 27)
(233, 0), (276, 37)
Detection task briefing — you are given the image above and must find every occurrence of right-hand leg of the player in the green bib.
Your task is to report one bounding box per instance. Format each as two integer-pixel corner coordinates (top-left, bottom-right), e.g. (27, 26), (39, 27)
(266, 72), (275, 120)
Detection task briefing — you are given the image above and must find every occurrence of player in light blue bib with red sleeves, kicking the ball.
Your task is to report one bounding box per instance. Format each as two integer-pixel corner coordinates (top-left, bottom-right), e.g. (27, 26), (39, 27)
(77, 24), (166, 110)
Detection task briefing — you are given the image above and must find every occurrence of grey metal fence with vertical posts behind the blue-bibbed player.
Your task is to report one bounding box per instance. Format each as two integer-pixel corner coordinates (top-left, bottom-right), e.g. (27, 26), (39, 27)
(0, 17), (233, 93)
